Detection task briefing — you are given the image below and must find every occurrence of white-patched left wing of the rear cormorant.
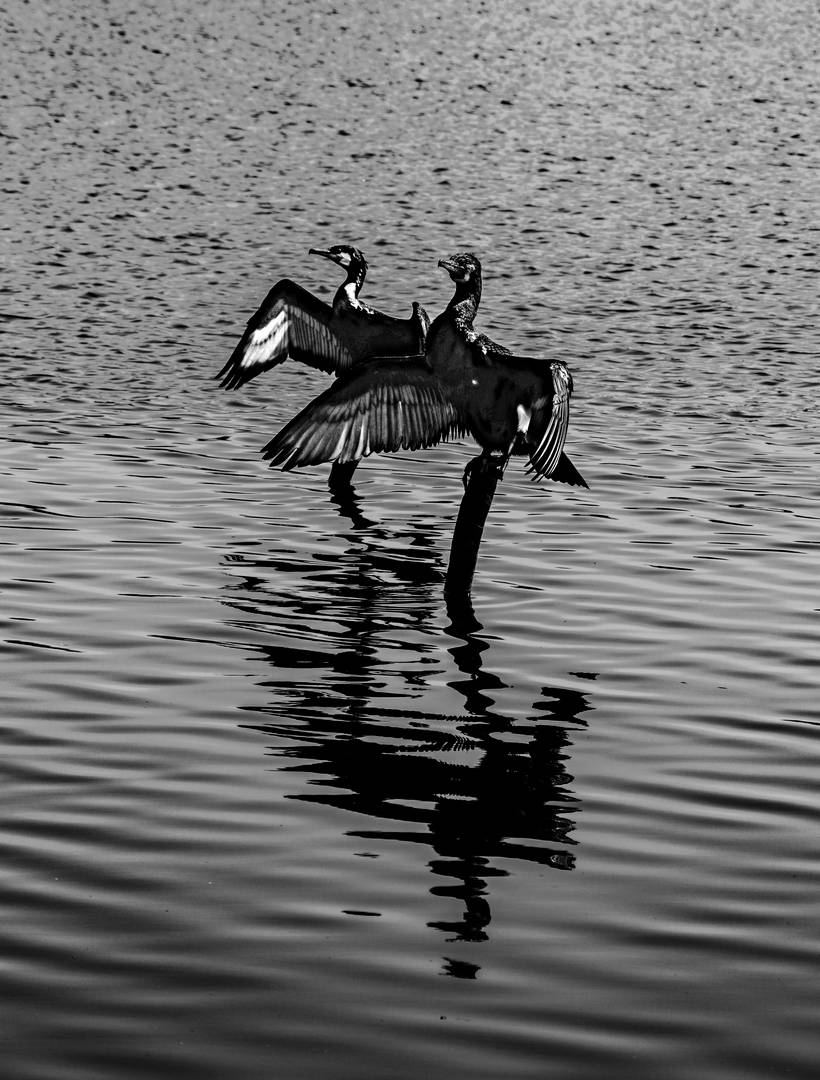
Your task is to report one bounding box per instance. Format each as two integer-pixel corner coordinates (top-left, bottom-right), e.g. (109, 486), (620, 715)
(217, 278), (352, 390)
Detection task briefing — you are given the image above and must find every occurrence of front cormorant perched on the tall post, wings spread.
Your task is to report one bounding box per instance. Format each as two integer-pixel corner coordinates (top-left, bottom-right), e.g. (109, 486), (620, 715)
(264, 253), (588, 487)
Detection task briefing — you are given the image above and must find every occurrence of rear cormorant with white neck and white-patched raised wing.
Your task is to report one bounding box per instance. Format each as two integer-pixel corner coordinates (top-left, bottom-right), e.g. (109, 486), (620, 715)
(217, 244), (430, 390)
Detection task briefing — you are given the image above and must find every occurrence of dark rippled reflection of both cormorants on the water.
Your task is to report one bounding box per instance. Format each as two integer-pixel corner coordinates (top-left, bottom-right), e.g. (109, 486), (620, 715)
(225, 491), (592, 977)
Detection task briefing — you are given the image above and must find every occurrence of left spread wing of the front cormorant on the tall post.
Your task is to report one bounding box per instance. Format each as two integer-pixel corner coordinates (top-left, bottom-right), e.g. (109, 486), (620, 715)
(263, 355), (461, 470)
